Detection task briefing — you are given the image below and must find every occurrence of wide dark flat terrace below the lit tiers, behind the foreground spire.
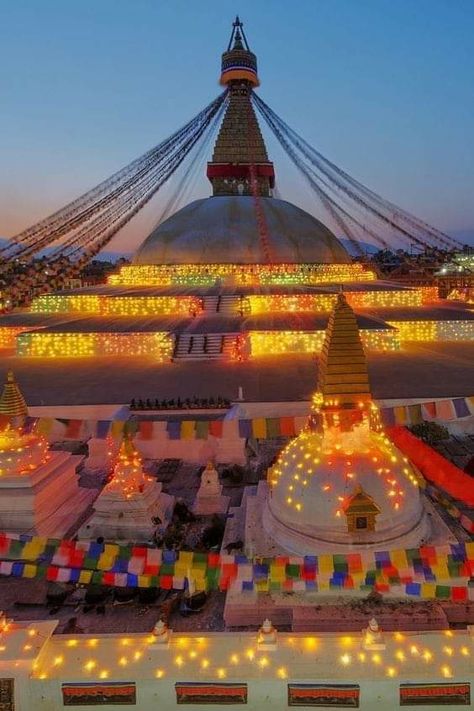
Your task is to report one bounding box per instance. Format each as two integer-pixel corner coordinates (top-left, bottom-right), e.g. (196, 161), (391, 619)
(0, 341), (474, 406)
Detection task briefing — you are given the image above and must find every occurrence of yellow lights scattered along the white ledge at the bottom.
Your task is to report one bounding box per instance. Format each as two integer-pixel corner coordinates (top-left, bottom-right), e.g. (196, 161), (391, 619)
(27, 629), (473, 693)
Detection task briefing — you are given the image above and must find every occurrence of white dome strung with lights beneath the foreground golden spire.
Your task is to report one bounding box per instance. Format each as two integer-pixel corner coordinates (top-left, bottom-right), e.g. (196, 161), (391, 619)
(263, 424), (429, 555)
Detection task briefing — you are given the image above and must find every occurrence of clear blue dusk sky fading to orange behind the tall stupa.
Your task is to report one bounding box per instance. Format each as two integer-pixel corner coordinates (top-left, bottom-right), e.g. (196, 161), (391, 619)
(0, 0), (474, 251)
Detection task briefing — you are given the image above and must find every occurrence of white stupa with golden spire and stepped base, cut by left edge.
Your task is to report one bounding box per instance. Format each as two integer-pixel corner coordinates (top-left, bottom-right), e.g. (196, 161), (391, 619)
(0, 370), (89, 537)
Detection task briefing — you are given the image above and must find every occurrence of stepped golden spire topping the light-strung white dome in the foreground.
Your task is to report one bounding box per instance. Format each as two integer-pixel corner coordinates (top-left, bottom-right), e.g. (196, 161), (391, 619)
(318, 292), (372, 407)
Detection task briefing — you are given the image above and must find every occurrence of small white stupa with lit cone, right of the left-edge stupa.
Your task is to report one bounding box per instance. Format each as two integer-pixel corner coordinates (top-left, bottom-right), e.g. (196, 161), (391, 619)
(79, 436), (174, 541)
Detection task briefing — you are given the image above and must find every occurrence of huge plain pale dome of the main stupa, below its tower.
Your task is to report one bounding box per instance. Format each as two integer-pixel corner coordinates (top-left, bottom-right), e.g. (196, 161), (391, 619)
(134, 196), (351, 264)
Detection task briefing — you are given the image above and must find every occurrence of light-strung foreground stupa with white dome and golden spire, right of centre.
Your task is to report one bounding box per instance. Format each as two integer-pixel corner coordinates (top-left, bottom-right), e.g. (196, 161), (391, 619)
(256, 293), (431, 555)
